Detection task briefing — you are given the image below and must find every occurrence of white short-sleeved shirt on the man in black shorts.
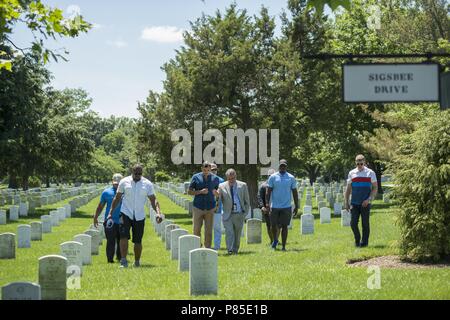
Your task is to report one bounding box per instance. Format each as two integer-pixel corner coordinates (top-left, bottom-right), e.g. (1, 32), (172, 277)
(118, 176), (155, 221)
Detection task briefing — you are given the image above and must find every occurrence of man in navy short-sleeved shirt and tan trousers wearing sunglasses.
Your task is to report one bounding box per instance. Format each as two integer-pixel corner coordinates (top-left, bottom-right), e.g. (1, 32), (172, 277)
(188, 161), (219, 248)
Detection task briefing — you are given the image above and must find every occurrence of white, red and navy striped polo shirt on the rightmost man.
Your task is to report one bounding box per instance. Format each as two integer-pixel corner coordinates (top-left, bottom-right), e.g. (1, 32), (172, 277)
(347, 167), (377, 205)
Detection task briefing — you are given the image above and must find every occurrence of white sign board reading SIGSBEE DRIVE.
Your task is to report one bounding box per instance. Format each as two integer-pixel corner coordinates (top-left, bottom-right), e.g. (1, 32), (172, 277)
(343, 63), (439, 103)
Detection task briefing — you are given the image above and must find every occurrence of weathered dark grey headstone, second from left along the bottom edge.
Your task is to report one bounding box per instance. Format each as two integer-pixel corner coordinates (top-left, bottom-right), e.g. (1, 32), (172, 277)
(39, 255), (67, 300)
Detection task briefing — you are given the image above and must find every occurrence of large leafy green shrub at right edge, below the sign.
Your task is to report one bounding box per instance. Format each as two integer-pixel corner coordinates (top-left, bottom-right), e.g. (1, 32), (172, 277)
(392, 110), (450, 262)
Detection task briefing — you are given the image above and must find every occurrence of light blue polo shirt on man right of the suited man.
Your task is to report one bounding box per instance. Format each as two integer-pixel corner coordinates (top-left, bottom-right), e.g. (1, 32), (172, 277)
(267, 172), (297, 209)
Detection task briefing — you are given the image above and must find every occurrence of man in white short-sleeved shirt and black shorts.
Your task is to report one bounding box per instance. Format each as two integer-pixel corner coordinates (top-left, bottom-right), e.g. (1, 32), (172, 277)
(108, 164), (162, 268)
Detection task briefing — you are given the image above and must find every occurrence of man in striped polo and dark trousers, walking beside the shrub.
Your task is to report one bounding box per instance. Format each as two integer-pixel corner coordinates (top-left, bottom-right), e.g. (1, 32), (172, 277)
(344, 154), (378, 247)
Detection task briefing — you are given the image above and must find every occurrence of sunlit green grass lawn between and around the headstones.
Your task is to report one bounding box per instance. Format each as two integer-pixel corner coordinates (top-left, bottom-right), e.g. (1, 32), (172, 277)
(0, 189), (450, 300)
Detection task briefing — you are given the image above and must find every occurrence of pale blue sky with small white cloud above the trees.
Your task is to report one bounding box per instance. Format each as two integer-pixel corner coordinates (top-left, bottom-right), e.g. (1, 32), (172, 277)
(13, 0), (326, 117)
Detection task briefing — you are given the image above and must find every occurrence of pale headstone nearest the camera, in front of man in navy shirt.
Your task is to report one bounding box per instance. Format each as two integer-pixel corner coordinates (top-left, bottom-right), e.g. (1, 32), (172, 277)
(189, 249), (218, 295)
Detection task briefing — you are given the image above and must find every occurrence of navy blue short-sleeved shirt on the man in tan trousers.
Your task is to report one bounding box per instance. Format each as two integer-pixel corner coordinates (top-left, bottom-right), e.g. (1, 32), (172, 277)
(189, 172), (220, 210)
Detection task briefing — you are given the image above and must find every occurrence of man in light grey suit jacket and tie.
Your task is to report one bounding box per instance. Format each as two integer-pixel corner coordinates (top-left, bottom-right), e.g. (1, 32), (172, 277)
(219, 169), (250, 254)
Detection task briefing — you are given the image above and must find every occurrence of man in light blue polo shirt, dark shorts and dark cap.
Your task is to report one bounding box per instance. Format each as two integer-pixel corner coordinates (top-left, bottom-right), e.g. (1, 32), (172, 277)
(266, 160), (298, 251)
